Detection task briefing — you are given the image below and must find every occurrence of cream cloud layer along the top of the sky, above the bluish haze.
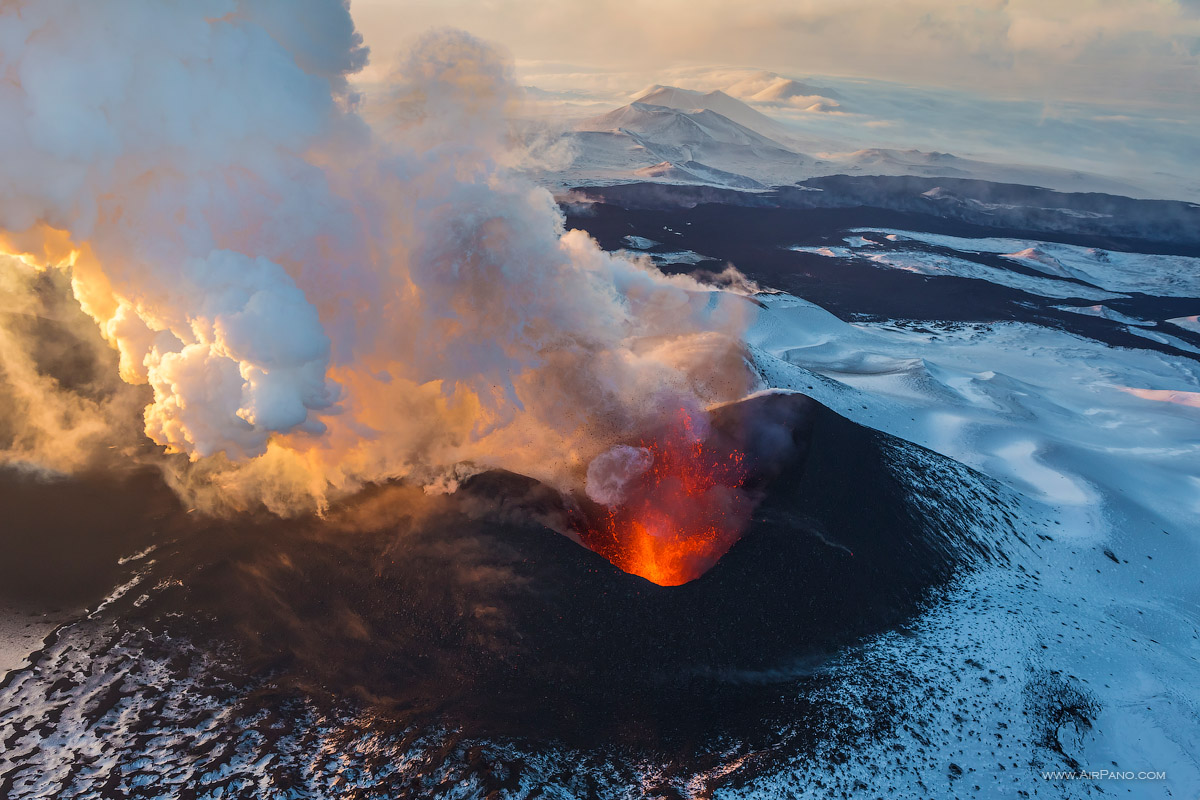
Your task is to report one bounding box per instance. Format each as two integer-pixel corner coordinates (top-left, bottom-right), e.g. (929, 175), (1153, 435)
(352, 0), (1200, 107)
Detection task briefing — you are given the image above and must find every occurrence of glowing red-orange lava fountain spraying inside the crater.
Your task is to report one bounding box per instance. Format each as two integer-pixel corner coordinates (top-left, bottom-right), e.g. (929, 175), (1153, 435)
(581, 409), (752, 587)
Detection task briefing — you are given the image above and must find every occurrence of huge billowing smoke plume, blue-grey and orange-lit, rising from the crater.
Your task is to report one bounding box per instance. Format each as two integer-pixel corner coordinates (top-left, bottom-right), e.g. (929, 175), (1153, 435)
(0, 0), (754, 512)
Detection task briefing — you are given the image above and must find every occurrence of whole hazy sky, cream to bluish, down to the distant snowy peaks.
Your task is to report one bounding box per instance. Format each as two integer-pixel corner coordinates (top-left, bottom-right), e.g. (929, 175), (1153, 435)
(350, 0), (1200, 201)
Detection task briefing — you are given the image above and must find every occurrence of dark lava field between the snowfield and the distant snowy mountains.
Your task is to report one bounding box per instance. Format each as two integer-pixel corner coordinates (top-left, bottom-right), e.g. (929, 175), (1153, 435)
(565, 189), (1200, 359)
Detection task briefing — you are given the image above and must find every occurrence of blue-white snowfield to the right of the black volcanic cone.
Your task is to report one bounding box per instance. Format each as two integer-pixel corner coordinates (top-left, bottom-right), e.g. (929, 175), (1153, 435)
(749, 295), (1200, 798)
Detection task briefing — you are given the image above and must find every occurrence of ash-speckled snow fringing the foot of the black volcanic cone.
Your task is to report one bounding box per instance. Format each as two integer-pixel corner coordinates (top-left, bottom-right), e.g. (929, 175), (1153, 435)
(0, 440), (1057, 800)
